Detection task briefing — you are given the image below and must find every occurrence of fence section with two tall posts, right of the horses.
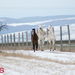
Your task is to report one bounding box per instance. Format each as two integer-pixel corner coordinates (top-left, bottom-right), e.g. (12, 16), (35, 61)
(56, 25), (75, 52)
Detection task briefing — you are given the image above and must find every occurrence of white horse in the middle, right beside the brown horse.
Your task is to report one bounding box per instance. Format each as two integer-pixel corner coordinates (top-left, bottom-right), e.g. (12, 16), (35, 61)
(37, 24), (46, 50)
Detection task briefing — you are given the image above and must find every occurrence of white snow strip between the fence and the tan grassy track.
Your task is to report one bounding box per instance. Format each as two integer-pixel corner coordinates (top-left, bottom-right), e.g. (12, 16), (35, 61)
(2, 50), (75, 64)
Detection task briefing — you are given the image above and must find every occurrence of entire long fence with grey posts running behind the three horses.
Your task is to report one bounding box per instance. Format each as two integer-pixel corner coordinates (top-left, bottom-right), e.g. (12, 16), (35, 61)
(0, 25), (75, 51)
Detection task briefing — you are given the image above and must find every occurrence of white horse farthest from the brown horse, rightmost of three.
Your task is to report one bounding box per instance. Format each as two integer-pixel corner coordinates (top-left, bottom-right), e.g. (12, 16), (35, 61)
(47, 25), (56, 51)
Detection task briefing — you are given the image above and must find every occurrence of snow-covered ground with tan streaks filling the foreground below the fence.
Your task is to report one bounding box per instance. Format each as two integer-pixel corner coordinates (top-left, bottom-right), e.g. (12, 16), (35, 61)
(0, 50), (75, 75)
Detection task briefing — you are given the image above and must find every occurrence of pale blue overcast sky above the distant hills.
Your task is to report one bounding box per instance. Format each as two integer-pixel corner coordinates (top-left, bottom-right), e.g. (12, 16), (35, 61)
(0, 0), (75, 18)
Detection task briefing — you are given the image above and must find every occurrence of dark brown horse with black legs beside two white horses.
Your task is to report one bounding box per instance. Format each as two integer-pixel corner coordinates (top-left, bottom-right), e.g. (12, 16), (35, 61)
(31, 29), (38, 52)
